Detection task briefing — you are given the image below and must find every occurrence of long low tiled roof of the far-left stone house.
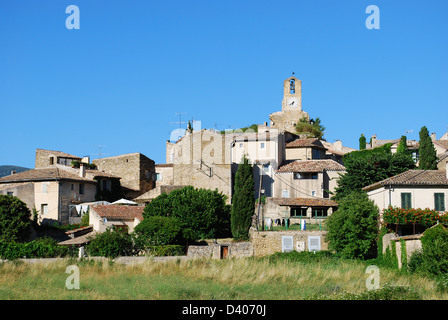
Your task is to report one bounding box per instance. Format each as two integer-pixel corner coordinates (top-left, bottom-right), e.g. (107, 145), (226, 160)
(0, 167), (96, 183)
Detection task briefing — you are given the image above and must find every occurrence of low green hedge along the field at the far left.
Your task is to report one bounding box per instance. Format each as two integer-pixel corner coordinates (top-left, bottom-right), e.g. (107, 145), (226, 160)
(0, 238), (77, 260)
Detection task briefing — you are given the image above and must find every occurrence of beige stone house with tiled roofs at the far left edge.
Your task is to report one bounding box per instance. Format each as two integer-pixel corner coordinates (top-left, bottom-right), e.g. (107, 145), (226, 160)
(0, 149), (121, 224)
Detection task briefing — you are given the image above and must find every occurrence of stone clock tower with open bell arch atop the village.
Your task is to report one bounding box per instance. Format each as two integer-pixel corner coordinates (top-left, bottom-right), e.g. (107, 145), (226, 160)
(269, 76), (310, 133)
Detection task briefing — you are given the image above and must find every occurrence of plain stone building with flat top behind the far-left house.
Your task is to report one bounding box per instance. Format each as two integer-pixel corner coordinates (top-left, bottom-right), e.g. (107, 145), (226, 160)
(92, 153), (155, 199)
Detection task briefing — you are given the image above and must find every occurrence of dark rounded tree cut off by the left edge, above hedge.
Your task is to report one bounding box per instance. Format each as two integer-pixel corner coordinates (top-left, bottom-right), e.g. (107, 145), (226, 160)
(0, 195), (31, 242)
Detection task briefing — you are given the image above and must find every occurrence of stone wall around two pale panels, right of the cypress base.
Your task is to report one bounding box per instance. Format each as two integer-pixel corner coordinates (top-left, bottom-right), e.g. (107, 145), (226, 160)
(250, 228), (328, 256)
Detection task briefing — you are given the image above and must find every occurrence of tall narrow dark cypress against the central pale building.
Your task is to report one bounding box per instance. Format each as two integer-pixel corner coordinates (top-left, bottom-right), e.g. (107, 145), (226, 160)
(230, 156), (255, 240)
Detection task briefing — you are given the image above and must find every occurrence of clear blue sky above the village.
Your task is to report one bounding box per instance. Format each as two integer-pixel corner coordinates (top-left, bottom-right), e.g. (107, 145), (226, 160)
(0, 0), (448, 168)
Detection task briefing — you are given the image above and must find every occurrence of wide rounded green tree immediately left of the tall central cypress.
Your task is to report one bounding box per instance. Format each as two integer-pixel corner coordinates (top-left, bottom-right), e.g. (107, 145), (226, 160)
(143, 186), (230, 240)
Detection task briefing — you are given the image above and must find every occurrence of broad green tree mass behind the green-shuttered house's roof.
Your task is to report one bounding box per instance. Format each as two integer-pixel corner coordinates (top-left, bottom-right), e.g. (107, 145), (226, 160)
(333, 144), (415, 200)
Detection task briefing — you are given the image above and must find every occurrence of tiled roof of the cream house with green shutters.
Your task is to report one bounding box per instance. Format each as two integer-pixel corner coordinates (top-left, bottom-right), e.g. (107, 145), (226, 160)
(363, 170), (448, 191)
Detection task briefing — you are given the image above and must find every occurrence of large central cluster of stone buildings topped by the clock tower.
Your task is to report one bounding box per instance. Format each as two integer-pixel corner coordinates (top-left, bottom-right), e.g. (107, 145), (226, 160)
(152, 77), (355, 225)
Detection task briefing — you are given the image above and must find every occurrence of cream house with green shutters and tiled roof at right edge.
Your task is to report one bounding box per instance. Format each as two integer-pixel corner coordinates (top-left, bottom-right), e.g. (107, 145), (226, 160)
(363, 162), (448, 212)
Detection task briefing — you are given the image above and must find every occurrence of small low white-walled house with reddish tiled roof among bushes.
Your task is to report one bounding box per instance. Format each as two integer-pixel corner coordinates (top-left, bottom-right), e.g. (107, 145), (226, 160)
(89, 205), (144, 233)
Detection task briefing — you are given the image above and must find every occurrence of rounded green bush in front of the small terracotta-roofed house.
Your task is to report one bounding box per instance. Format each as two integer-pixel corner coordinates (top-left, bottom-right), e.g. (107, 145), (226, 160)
(86, 228), (134, 258)
